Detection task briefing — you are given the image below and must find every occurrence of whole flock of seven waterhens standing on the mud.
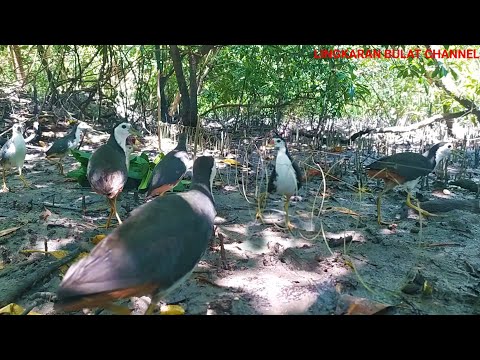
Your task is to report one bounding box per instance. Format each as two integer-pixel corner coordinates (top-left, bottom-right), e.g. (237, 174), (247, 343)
(0, 122), (452, 314)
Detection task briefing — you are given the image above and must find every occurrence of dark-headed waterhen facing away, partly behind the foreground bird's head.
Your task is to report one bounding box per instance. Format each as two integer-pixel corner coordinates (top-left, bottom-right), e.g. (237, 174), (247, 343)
(147, 133), (188, 199)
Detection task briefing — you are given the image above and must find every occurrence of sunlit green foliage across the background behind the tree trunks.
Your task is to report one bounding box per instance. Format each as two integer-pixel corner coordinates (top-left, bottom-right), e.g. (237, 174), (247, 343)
(0, 45), (480, 131)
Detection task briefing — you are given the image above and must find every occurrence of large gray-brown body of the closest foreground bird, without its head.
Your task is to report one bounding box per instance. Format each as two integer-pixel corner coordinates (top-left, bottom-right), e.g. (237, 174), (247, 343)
(55, 188), (215, 297)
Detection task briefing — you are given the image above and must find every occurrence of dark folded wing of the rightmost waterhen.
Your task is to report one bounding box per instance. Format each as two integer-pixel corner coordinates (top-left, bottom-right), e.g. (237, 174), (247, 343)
(367, 152), (433, 181)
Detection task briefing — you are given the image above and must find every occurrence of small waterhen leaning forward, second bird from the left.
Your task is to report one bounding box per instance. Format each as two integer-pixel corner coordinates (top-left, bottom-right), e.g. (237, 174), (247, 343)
(45, 121), (91, 175)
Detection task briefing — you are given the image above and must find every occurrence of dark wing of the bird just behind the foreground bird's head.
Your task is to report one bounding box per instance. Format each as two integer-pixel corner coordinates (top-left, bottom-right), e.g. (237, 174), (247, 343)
(148, 150), (188, 194)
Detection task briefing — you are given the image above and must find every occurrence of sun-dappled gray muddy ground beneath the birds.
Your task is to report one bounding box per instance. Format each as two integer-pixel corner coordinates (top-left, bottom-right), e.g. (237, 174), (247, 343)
(0, 133), (480, 315)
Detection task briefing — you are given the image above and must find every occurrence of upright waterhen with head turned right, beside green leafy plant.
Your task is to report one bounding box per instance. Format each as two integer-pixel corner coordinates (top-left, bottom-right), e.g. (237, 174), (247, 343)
(87, 122), (139, 228)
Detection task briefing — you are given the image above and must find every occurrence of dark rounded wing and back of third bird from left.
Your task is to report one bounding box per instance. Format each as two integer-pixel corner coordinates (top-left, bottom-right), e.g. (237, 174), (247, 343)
(87, 144), (128, 197)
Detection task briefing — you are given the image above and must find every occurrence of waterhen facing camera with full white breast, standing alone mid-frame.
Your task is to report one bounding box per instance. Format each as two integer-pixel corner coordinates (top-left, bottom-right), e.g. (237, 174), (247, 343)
(256, 135), (302, 229)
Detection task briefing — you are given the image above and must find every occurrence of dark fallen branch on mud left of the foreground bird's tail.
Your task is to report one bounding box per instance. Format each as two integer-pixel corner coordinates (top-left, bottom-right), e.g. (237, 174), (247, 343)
(0, 249), (81, 307)
